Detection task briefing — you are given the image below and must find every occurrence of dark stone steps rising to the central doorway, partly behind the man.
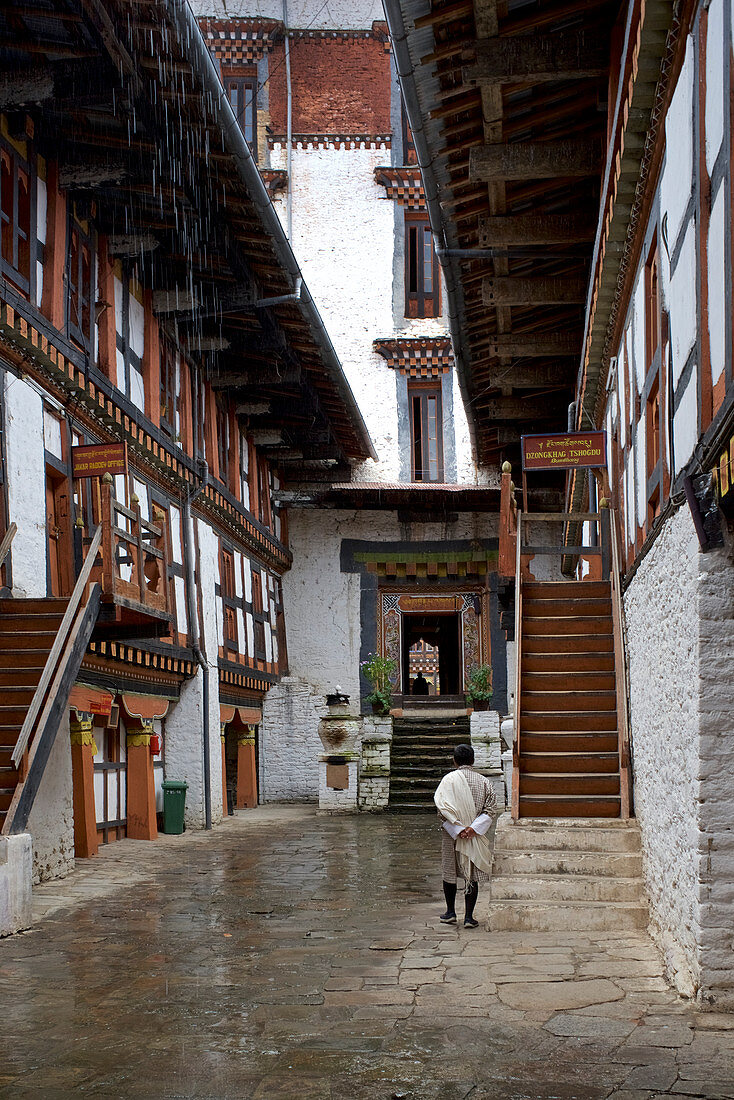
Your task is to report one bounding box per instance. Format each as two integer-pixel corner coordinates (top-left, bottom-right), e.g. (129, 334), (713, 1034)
(388, 712), (471, 813)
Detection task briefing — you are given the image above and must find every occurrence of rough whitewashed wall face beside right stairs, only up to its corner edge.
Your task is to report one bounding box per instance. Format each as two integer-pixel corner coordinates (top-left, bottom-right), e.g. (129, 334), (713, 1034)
(624, 508), (700, 996)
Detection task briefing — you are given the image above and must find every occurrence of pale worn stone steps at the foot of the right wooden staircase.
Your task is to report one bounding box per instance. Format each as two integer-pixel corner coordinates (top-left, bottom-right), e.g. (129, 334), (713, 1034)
(487, 814), (648, 932)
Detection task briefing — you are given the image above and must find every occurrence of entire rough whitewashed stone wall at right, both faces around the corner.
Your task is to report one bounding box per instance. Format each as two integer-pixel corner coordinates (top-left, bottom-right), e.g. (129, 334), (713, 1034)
(624, 506), (734, 1007)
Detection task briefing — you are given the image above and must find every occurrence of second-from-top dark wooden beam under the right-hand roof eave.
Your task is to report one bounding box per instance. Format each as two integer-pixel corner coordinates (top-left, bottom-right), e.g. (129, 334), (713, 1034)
(469, 139), (601, 184)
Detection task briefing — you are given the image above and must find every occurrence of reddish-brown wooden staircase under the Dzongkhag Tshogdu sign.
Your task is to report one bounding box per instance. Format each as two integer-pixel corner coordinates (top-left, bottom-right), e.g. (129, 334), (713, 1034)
(516, 581), (623, 817)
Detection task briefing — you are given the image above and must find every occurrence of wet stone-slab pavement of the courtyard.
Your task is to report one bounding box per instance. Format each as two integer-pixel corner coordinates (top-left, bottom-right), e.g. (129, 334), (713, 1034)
(0, 806), (734, 1100)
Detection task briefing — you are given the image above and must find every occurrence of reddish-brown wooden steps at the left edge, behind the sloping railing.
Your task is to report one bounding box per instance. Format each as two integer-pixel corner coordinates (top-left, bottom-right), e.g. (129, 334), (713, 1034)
(0, 598), (68, 833)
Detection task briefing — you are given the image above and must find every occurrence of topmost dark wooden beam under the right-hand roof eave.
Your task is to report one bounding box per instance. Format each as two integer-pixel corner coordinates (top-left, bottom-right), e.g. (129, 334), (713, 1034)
(462, 31), (609, 87)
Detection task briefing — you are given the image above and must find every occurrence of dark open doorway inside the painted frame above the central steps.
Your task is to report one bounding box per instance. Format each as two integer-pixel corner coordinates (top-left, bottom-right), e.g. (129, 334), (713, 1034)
(402, 613), (462, 697)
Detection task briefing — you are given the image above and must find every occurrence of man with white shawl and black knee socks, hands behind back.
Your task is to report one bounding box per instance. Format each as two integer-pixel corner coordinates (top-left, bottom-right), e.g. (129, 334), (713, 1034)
(434, 745), (499, 928)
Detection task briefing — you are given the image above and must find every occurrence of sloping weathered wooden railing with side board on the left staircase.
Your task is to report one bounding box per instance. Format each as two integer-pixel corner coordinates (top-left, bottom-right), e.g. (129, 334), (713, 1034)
(2, 525), (102, 835)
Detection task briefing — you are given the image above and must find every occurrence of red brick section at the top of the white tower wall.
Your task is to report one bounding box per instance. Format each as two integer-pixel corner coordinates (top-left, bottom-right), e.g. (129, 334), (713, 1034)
(270, 37), (392, 134)
